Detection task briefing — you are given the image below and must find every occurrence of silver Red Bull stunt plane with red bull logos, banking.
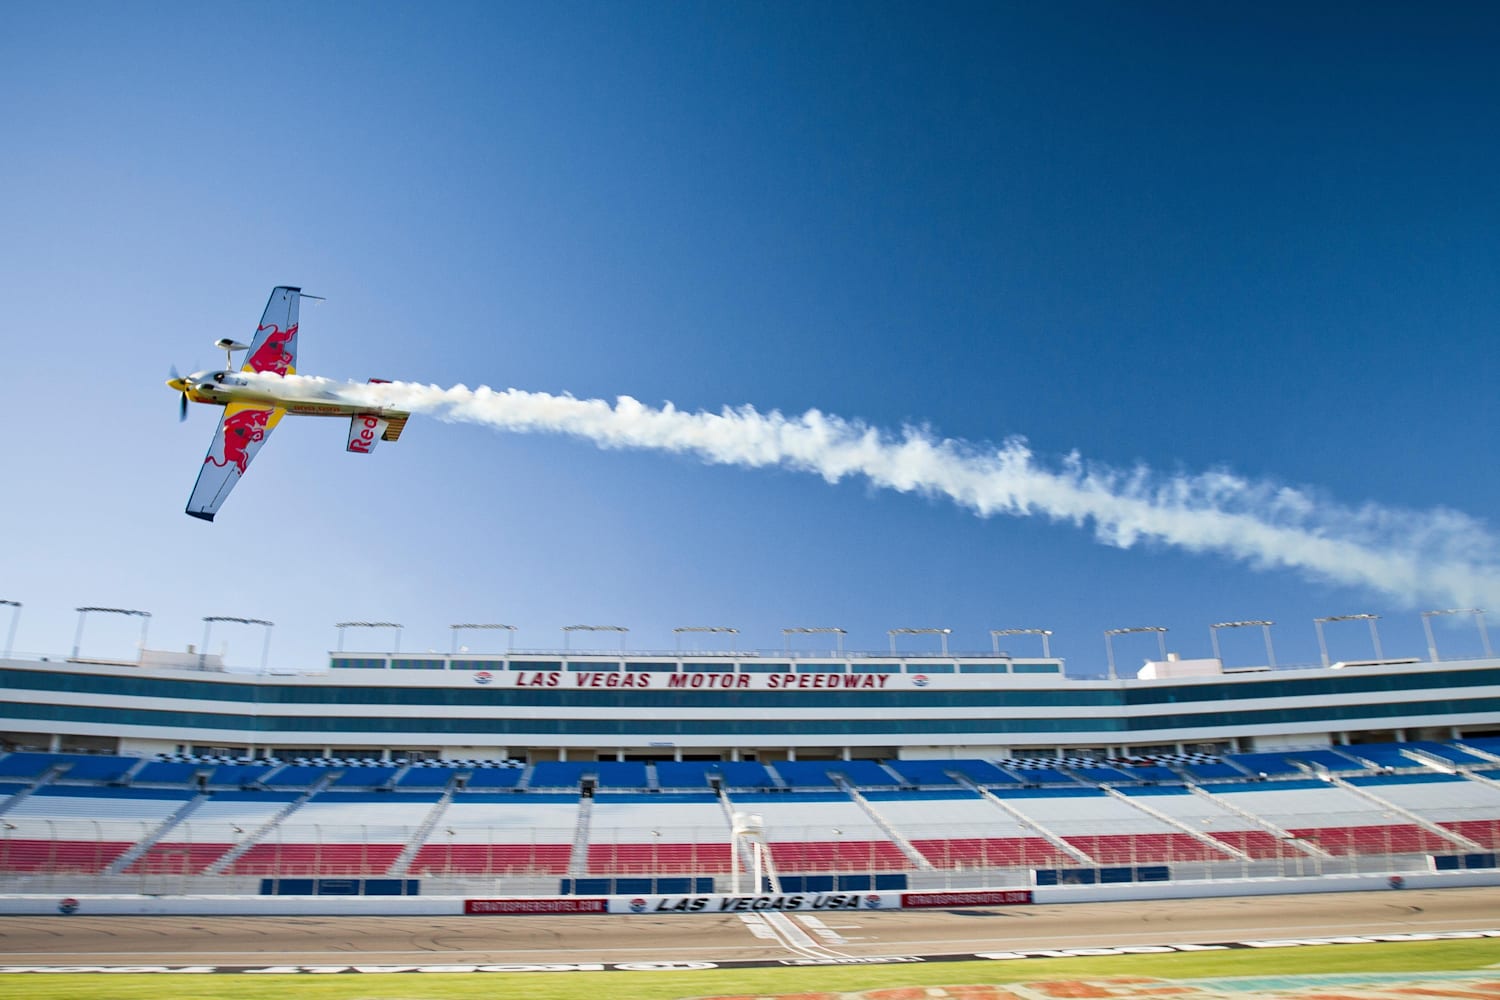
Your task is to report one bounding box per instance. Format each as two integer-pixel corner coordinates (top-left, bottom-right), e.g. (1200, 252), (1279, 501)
(167, 285), (411, 520)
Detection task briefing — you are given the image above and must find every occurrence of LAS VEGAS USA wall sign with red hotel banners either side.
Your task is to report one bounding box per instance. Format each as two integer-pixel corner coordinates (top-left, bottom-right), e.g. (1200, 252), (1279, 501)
(464, 889), (1032, 916)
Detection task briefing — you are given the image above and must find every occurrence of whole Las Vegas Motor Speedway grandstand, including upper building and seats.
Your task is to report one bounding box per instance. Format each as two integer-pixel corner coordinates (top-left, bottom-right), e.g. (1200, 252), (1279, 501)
(0, 620), (1500, 894)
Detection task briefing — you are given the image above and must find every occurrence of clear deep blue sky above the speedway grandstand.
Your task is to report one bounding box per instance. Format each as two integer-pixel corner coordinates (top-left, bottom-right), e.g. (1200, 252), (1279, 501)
(0, 1), (1500, 673)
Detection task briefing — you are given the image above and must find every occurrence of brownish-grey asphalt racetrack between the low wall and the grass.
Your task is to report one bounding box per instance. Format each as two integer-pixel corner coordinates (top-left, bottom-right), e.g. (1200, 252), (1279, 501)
(0, 888), (1500, 966)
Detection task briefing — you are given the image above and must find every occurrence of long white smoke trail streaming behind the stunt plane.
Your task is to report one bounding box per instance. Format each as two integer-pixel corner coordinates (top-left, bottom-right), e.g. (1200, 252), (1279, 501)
(270, 376), (1500, 607)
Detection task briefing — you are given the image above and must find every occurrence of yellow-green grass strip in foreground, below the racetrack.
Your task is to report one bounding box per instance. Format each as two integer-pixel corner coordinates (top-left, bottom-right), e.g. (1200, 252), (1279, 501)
(0, 939), (1500, 1000)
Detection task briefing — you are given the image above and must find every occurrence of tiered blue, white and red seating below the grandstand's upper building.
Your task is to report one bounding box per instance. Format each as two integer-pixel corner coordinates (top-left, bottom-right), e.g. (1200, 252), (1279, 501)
(0, 739), (1500, 879)
